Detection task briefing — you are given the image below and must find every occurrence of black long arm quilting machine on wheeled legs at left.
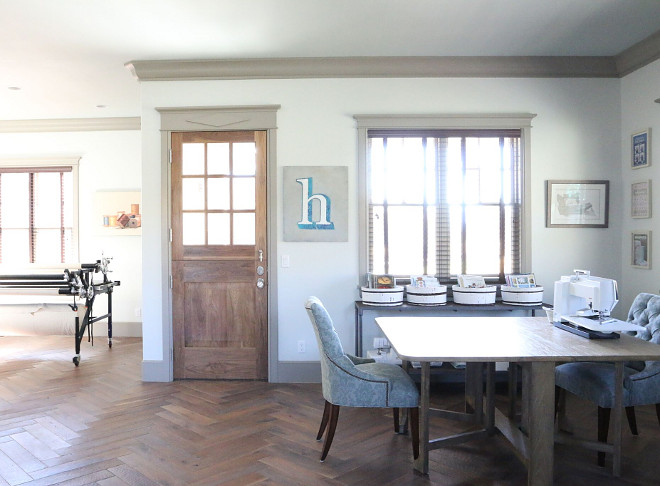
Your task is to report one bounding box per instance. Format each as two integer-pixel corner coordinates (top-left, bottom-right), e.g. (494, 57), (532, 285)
(0, 257), (120, 366)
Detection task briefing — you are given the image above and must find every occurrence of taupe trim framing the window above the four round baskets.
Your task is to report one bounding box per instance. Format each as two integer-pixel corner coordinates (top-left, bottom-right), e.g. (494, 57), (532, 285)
(353, 113), (536, 280)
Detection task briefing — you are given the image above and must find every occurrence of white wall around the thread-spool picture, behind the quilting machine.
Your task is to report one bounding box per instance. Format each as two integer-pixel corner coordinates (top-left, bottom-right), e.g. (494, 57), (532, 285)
(0, 130), (142, 335)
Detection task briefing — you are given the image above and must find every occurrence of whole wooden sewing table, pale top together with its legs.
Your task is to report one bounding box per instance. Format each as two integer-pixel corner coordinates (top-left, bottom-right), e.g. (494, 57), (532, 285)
(376, 316), (660, 485)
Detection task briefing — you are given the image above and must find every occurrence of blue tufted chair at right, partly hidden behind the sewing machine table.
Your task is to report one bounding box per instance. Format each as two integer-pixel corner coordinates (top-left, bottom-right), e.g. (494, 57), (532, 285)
(555, 293), (660, 466)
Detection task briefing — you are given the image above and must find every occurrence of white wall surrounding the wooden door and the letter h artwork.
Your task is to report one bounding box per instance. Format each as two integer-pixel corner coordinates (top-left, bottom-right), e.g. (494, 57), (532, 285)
(142, 75), (622, 376)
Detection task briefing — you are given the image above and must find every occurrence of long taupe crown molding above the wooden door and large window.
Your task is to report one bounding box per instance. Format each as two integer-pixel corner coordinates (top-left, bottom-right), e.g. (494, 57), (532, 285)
(125, 56), (618, 81)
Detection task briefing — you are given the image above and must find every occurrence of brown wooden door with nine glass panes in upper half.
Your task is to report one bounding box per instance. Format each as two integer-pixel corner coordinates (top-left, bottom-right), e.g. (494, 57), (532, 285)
(171, 131), (268, 380)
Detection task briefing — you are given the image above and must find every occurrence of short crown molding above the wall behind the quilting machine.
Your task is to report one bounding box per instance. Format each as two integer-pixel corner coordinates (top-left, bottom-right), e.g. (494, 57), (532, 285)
(0, 117), (141, 133)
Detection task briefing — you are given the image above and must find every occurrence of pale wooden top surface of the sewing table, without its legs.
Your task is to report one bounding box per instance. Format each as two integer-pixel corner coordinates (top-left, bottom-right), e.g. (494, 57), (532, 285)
(376, 316), (660, 362)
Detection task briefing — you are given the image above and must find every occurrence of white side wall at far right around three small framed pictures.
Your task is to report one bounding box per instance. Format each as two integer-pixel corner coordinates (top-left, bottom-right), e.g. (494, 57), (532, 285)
(620, 61), (660, 311)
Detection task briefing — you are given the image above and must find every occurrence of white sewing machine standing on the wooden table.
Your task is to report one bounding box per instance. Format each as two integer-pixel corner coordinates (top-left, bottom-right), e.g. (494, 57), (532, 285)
(553, 270), (641, 338)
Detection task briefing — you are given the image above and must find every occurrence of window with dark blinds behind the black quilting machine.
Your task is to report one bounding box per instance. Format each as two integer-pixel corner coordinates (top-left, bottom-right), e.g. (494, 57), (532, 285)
(0, 161), (78, 265)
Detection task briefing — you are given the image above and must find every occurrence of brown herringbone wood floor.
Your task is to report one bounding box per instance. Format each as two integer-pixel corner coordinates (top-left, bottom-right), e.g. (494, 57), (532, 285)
(0, 336), (660, 486)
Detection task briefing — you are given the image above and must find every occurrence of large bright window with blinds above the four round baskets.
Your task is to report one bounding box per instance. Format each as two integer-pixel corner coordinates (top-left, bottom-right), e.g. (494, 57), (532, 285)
(356, 117), (527, 283)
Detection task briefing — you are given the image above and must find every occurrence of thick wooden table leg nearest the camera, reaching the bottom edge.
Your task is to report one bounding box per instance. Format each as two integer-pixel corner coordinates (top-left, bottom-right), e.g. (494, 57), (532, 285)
(523, 361), (555, 486)
